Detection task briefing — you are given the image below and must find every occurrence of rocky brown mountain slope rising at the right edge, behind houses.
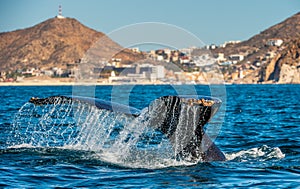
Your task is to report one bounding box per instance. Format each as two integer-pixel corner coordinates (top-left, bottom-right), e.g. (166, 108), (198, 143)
(213, 12), (300, 83)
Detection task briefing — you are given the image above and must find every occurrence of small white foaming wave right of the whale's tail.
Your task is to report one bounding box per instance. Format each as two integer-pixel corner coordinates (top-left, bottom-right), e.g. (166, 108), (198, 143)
(225, 145), (285, 162)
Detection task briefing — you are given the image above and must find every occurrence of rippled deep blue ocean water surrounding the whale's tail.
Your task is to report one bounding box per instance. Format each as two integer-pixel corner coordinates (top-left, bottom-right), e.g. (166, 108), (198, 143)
(0, 85), (300, 188)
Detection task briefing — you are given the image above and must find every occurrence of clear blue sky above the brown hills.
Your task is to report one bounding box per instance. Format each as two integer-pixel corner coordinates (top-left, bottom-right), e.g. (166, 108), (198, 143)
(0, 0), (300, 44)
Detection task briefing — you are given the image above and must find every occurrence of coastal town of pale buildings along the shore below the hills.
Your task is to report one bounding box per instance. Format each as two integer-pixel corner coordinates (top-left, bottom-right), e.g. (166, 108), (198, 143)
(0, 39), (290, 84)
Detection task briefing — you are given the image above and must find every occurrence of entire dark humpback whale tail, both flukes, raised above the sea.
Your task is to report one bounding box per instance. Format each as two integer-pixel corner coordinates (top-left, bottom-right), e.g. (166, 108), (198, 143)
(29, 96), (225, 161)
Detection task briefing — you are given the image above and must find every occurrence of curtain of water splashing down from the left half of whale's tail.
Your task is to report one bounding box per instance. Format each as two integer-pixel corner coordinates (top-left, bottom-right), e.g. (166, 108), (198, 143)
(7, 101), (175, 168)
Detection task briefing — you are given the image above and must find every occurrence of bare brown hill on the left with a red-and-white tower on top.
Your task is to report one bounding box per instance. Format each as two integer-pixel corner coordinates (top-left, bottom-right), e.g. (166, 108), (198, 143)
(0, 17), (143, 71)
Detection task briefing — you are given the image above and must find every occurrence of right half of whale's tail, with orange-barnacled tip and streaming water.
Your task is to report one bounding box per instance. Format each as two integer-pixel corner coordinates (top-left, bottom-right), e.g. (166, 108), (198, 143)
(145, 96), (225, 161)
